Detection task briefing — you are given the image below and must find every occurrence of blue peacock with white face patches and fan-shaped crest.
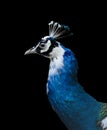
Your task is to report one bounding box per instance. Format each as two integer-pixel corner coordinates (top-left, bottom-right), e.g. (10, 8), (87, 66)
(25, 21), (107, 130)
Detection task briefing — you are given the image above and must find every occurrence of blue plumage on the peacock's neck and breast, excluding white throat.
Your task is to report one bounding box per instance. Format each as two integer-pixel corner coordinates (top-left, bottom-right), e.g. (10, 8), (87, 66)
(48, 48), (100, 130)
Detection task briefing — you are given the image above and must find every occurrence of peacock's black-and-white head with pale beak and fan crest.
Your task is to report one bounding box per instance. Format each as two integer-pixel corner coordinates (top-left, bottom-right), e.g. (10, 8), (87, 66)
(25, 21), (70, 59)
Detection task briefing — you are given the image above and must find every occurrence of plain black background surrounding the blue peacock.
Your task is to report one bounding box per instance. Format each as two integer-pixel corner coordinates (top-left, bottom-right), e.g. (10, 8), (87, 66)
(6, 1), (107, 130)
